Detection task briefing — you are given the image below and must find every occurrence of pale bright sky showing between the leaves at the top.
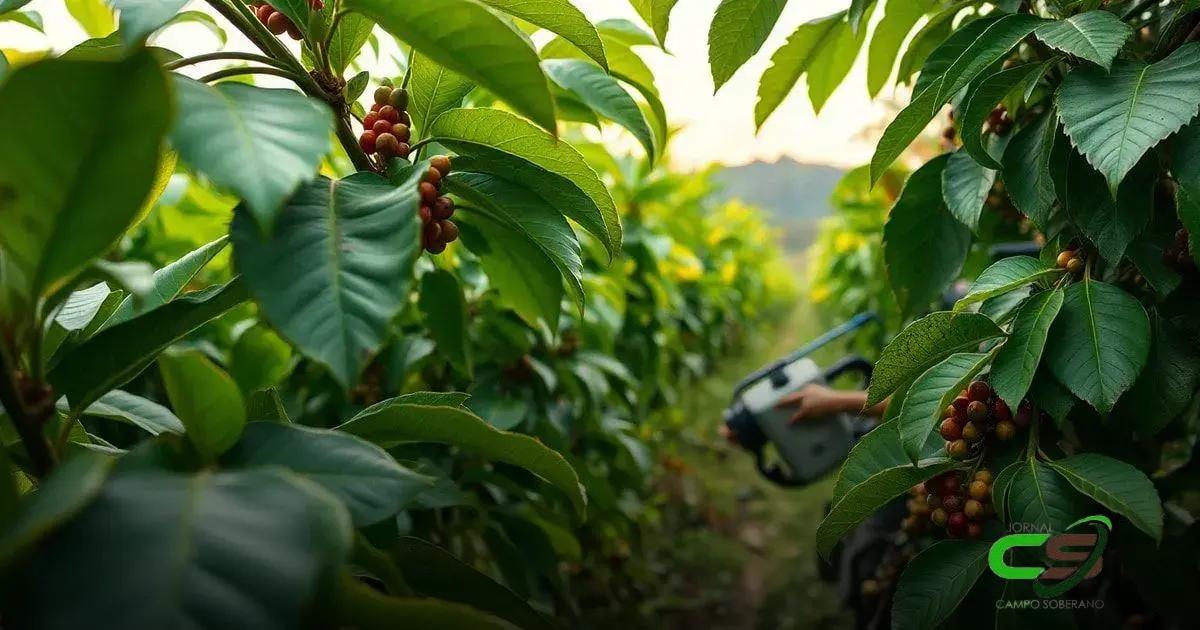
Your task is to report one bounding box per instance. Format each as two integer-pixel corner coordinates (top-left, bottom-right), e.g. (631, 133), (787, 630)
(0, 0), (893, 169)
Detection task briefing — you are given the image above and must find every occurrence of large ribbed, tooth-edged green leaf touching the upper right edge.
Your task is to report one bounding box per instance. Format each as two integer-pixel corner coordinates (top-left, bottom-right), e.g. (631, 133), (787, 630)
(1058, 42), (1200, 191)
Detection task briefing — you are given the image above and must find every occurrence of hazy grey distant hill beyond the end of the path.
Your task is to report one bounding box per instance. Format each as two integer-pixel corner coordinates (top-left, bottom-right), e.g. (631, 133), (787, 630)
(715, 157), (842, 251)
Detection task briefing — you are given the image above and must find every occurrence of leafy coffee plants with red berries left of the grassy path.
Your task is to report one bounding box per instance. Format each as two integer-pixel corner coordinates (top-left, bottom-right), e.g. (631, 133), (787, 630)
(0, 0), (791, 630)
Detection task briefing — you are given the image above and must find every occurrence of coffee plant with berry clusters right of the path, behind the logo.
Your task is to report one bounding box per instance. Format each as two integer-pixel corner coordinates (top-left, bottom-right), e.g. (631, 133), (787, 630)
(700, 0), (1200, 629)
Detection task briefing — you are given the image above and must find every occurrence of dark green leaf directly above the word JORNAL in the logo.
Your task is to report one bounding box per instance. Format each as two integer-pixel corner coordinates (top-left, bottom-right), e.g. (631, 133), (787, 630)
(1004, 457), (1091, 533)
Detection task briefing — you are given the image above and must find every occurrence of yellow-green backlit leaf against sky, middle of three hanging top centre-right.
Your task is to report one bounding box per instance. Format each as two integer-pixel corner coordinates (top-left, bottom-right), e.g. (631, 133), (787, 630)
(754, 11), (862, 130)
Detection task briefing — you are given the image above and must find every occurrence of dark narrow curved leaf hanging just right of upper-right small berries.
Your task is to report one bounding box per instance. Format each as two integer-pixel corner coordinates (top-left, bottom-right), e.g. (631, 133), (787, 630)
(1001, 112), (1058, 228)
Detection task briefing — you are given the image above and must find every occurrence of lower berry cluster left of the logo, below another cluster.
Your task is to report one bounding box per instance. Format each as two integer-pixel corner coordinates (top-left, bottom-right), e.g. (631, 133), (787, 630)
(922, 468), (996, 538)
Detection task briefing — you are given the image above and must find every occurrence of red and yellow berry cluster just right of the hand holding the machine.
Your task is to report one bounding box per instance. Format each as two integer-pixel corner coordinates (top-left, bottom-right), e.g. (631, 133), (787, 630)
(938, 380), (1033, 460)
